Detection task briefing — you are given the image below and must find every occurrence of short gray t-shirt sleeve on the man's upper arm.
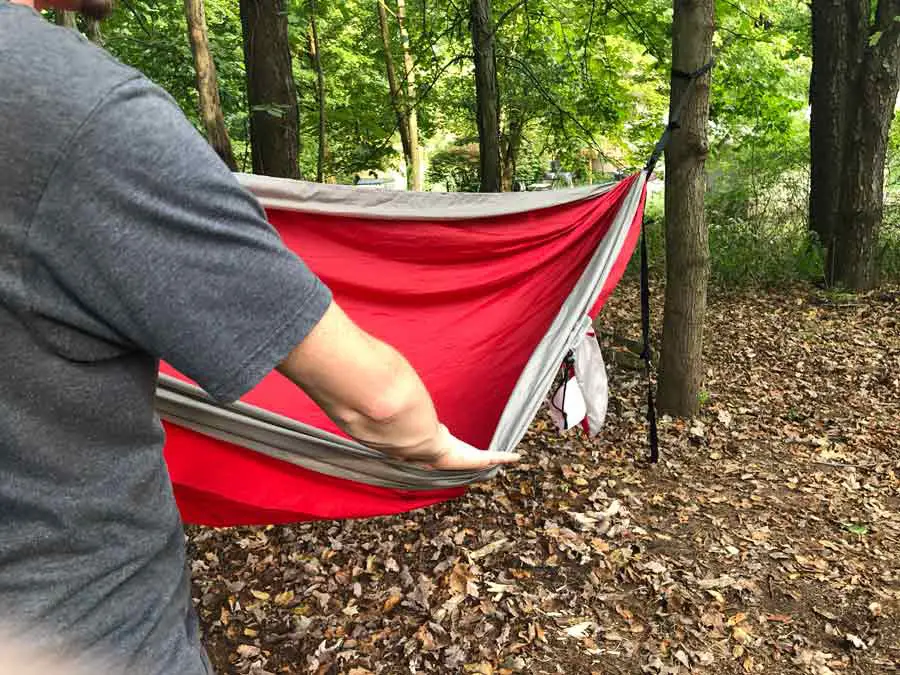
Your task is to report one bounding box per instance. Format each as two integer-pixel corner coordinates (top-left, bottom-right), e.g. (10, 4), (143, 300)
(28, 78), (331, 401)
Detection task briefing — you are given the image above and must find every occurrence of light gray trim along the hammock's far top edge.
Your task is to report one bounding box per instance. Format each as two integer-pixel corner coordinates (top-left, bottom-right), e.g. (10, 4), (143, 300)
(234, 173), (618, 221)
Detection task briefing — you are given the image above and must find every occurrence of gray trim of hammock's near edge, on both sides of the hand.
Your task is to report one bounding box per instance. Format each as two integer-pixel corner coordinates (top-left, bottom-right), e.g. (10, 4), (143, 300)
(156, 173), (646, 490)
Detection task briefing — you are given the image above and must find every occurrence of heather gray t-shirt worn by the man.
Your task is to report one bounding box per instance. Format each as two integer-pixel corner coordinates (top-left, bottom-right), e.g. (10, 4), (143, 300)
(0, 0), (331, 675)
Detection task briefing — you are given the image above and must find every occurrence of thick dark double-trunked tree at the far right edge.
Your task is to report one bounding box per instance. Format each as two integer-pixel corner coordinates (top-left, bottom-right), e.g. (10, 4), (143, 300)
(809, 0), (900, 290)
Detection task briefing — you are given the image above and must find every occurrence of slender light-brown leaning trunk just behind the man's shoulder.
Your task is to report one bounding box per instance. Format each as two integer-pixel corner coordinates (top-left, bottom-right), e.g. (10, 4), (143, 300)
(184, 0), (237, 171)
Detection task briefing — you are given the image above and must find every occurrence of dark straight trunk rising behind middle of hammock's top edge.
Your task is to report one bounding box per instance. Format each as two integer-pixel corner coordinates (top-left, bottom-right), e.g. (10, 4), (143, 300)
(469, 0), (501, 192)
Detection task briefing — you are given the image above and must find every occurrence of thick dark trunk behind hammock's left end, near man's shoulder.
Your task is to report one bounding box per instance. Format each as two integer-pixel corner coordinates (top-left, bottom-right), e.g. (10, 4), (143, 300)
(240, 0), (300, 178)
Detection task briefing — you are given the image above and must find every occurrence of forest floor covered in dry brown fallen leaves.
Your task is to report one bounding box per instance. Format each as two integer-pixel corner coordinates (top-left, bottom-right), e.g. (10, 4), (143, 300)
(189, 283), (900, 675)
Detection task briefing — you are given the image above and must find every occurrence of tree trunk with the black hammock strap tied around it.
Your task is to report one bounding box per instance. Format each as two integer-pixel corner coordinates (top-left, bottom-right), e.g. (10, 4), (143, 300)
(659, 0), (715, 417)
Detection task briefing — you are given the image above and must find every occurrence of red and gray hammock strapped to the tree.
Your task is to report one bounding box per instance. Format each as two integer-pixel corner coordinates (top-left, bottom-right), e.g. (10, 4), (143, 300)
(157, 172), (647, 526)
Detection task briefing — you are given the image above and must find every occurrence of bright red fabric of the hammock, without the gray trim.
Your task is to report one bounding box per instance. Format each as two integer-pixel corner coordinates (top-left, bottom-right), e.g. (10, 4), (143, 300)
(162, 177), (646, 526)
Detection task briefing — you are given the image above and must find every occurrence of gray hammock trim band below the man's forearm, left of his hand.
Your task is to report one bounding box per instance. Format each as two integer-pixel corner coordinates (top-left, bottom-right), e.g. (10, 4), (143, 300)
(156, 373), (497, 490)
